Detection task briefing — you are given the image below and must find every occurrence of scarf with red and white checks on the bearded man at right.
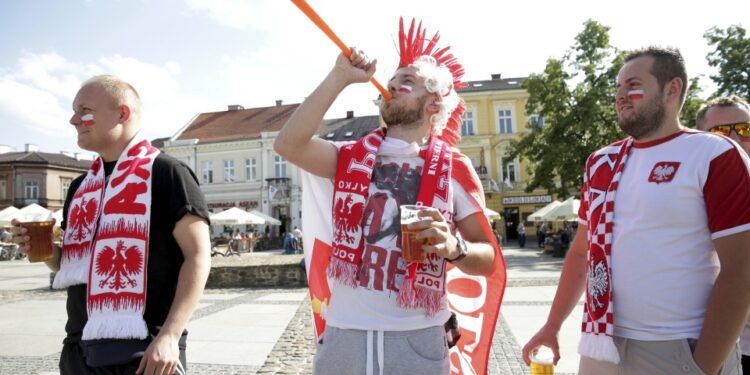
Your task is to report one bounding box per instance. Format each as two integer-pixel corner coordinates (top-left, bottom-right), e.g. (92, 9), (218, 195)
(578, 138), (633, 363)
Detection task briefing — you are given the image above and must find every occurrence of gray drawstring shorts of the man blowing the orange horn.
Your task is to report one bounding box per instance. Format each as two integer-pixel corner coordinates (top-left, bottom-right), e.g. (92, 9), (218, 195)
(313, 326), (450, 375)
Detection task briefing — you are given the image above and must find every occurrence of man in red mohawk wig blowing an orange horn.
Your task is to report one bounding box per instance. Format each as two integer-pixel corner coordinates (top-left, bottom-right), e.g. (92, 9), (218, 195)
(274, 16), (505, 374)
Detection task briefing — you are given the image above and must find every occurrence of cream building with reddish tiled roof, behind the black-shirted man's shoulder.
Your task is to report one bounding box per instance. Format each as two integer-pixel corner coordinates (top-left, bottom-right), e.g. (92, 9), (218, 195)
(161, 100), (378, 237)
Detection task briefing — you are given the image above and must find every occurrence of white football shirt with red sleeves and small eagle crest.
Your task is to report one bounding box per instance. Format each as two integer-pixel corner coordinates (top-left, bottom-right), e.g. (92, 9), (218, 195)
(581, 130), (750, 341)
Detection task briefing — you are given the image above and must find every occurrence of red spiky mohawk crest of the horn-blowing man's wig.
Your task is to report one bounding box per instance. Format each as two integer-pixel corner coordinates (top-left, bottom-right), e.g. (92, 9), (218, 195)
(398, 17), (466, 146)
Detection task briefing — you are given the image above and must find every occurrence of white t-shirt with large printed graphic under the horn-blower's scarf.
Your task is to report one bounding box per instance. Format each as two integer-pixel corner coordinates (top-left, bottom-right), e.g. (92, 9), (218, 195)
(326, 137), (478, 331)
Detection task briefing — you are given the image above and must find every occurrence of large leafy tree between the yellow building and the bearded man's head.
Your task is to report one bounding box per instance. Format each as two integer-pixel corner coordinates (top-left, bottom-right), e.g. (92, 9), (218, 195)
(504, 20), (625, 197)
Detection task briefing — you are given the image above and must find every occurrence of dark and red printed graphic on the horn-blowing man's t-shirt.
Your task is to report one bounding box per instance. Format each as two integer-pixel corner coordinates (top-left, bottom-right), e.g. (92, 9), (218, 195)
(359, 162), (422, 296)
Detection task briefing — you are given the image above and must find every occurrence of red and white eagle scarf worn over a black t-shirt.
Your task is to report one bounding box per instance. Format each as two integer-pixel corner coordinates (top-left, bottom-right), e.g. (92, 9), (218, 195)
(53, 136), (159, 340)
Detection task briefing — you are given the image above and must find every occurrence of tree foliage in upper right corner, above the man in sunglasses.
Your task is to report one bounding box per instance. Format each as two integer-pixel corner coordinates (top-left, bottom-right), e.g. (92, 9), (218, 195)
(703, 25), (750, 100)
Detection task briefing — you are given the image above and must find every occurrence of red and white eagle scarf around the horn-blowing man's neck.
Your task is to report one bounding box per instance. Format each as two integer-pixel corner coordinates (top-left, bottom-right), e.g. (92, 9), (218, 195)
(328, 128), (452, 316)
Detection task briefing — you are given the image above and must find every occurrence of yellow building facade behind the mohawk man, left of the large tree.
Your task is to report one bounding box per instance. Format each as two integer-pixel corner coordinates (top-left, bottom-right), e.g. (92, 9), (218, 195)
(458, 74), (553, 239)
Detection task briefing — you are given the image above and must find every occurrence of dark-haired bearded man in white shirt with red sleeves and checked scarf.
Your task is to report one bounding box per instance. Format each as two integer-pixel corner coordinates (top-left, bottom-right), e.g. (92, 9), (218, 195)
(524, 47), (750, 375)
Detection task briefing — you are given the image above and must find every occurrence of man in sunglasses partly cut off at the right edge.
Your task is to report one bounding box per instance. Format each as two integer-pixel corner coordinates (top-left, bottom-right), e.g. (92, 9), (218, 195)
(696, 95), (750, 374)
